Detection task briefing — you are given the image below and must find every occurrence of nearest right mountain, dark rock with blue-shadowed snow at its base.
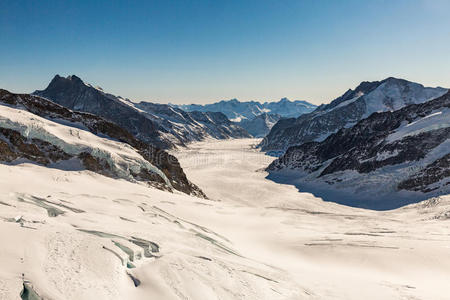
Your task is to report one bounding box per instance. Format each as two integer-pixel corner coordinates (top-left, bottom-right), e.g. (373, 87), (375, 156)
(267, 92), (450, 209)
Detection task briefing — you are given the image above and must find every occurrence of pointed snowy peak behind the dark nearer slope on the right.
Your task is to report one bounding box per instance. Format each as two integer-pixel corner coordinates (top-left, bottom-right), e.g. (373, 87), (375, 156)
(260, 77), (447, 153)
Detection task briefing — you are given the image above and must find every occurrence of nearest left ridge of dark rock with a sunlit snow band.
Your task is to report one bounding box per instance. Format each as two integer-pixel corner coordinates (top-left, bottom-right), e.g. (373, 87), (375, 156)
(0, 90), (204, 197)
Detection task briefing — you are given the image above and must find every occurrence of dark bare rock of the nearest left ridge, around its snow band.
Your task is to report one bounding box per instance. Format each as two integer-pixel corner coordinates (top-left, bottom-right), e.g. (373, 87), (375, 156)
(0, 89), (205, 197)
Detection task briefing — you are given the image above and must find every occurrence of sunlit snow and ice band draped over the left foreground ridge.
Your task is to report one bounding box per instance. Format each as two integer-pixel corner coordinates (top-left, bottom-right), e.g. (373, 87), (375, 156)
(0, 105), (171, 186)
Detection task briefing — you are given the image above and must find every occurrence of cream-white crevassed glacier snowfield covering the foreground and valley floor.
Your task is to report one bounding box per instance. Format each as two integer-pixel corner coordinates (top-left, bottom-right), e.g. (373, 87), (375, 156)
(0, 139), (450, 300)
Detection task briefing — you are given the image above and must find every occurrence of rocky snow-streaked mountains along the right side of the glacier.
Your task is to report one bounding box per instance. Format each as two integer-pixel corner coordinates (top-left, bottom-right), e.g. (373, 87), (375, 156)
(265, 84), (450, 209)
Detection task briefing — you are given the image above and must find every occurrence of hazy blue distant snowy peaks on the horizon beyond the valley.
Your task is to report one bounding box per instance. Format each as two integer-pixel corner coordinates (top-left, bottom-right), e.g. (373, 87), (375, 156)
(172, 98), (317, 122)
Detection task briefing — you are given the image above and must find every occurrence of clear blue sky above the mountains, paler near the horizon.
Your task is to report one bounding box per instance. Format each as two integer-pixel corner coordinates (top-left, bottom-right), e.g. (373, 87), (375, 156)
(0, 0), (450, 104)
